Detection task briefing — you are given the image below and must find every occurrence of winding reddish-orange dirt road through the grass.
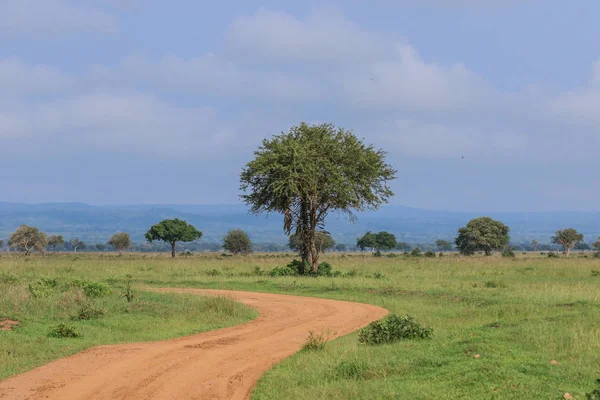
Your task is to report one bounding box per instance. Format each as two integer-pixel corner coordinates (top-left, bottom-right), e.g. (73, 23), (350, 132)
(0, 289), (387, 400)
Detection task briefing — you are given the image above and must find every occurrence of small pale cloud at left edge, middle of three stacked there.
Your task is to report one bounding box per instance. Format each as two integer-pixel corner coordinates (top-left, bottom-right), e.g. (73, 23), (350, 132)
(0, 57), (75, 96)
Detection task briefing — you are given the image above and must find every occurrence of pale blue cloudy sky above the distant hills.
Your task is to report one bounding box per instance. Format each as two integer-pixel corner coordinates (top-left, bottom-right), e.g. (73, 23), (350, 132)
(0, 0), (600, 211)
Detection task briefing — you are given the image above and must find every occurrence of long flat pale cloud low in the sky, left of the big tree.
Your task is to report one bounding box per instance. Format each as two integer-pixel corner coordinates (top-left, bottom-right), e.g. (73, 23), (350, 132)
(0, 93), (233, 155)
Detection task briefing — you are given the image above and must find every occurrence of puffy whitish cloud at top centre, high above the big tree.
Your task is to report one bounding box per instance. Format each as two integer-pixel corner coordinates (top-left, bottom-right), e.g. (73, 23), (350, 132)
(227, 8), (385, 64)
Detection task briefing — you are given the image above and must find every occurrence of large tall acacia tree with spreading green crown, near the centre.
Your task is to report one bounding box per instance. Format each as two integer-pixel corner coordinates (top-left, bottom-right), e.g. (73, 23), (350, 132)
(240, 123), (396, 273)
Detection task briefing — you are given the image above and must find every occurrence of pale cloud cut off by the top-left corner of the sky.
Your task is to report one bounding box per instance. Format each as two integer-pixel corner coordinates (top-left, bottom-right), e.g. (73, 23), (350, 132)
(0, 0), (117, 39)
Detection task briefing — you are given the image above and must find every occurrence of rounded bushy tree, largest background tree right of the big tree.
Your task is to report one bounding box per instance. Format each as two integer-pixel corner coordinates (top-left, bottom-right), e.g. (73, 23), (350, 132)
(455, 217), (510, 256)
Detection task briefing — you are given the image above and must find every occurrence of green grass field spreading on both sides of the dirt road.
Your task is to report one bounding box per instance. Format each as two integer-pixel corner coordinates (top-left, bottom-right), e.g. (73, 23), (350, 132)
(0, 254), (600, 399)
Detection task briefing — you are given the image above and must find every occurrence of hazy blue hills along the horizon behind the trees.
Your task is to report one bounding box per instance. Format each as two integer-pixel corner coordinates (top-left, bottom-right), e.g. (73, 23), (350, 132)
(0, 202), (600, 244)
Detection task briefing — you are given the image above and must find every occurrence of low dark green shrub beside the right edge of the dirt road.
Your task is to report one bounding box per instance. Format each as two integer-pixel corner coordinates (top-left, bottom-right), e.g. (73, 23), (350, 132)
(358, 314), (433, 345)
